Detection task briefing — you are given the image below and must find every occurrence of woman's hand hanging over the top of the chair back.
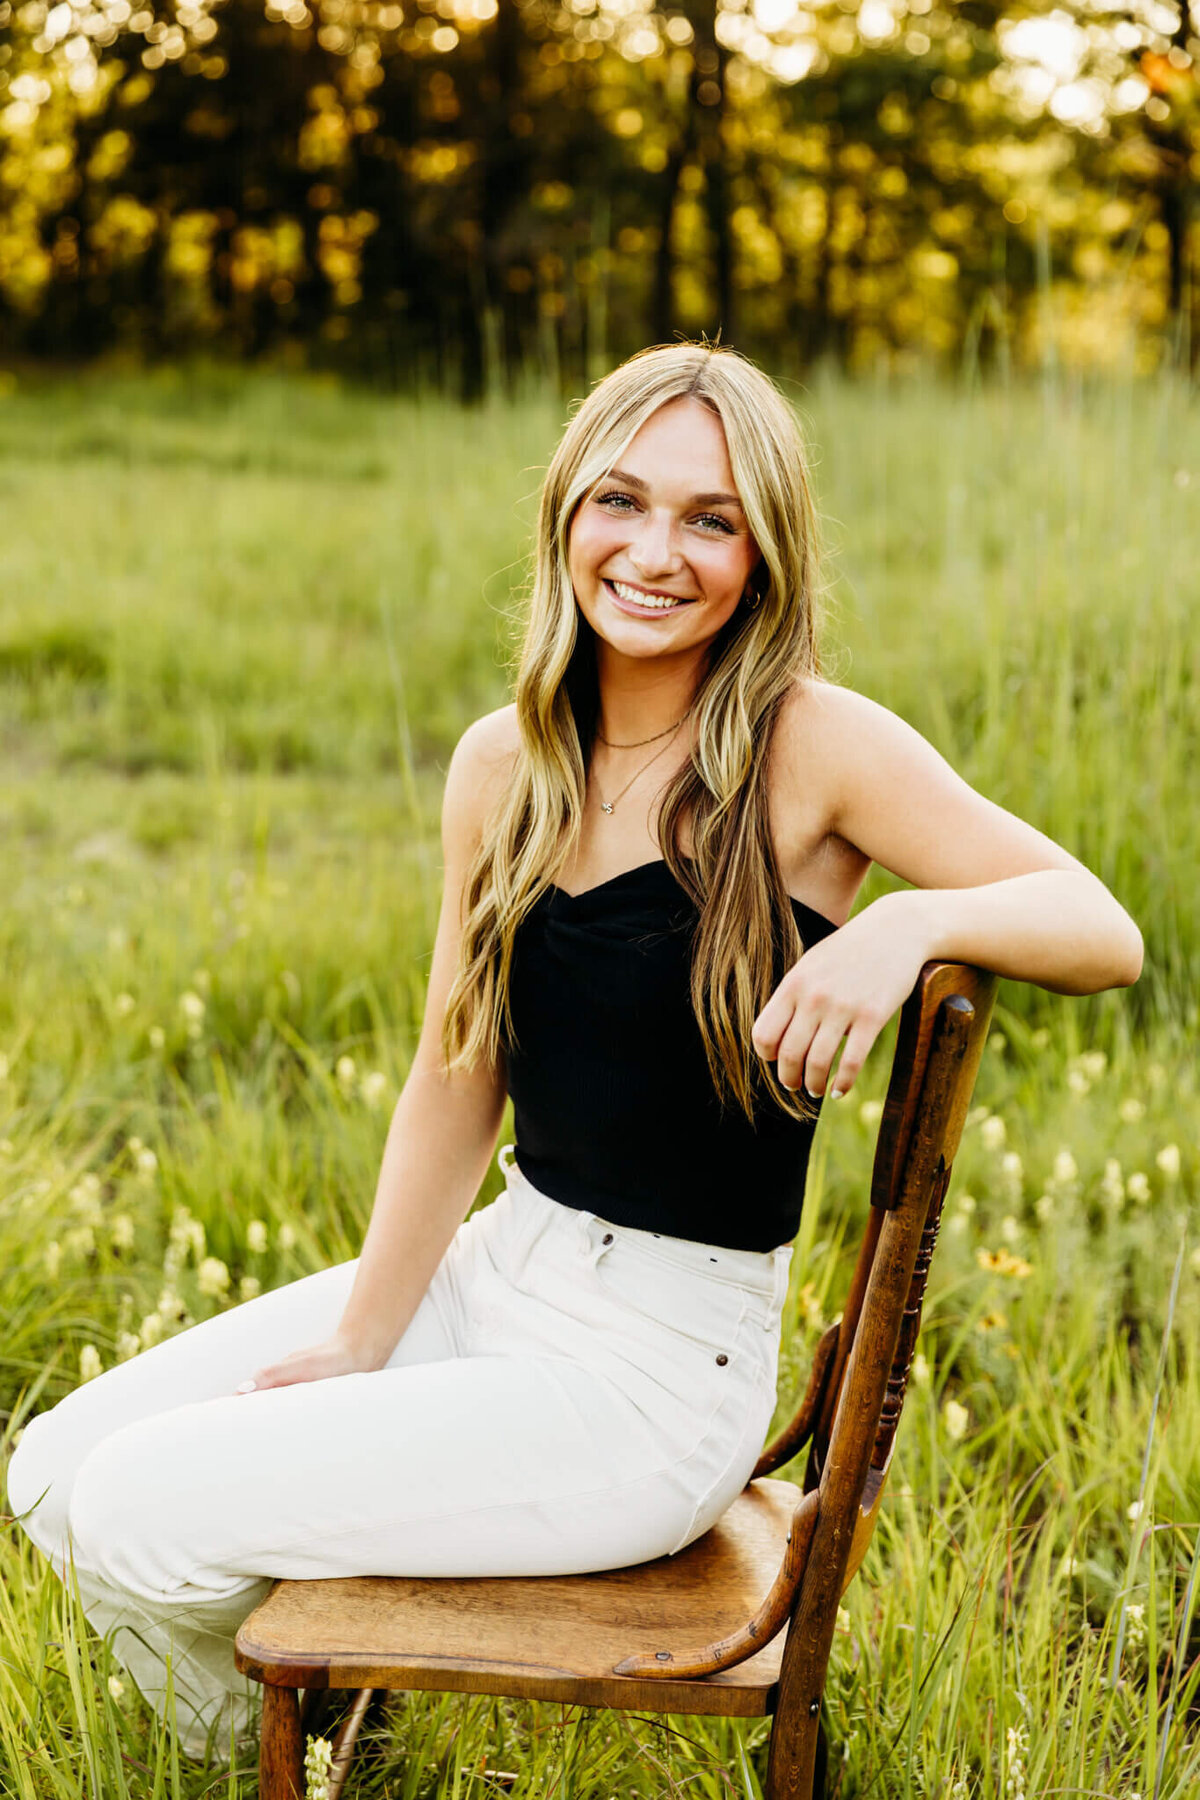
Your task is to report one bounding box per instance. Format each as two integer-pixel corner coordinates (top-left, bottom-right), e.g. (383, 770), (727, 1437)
(750, 889), (932, 1100)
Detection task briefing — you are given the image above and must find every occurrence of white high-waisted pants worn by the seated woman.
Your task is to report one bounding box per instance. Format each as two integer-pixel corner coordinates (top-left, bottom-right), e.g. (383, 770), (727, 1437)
(9, 1145), (792, 1748)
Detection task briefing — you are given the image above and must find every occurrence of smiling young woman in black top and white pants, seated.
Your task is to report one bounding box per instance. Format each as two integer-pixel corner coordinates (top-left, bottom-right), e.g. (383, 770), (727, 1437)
(9, 344), (1142, 1748)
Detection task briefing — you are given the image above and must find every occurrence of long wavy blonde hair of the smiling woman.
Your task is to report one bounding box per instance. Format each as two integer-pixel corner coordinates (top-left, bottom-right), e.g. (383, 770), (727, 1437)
(443, 344), (820, 1121)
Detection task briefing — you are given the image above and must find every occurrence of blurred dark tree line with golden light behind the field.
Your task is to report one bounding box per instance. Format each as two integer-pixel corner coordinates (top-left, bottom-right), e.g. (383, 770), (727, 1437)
(0, 0), (1200, 394)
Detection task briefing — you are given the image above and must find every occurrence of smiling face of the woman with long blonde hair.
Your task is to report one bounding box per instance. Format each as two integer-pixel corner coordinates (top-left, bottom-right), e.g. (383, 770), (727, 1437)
(567, 400), (759, 657)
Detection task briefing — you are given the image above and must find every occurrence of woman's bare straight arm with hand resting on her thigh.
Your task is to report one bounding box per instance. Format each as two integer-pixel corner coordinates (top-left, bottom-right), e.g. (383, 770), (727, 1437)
(235, 706), (515, 1388)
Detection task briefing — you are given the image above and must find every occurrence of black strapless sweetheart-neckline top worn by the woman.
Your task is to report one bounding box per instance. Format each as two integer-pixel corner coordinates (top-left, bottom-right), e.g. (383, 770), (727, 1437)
(506, 857), (837, 1251)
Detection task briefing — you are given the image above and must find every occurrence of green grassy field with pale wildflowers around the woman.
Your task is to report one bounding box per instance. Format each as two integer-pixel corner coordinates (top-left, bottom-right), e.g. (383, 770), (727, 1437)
(0, 371), (1200, 1800)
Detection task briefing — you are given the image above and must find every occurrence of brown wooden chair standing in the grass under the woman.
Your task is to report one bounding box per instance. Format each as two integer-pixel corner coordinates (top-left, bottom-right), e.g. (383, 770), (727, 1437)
(236, 963), (997, 1800)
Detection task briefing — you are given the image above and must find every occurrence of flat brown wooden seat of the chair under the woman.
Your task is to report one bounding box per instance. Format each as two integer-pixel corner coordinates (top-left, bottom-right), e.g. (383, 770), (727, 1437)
(236, 1480), (799, 1717)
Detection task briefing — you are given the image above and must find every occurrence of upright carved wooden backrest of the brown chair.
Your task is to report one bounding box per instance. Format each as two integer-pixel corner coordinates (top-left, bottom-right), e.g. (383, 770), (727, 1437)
(781, 963), (997, 1749)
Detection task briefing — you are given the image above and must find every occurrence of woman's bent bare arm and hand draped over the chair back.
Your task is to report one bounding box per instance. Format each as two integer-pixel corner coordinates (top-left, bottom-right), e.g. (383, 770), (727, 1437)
(754, 684), (1142, 1094)
